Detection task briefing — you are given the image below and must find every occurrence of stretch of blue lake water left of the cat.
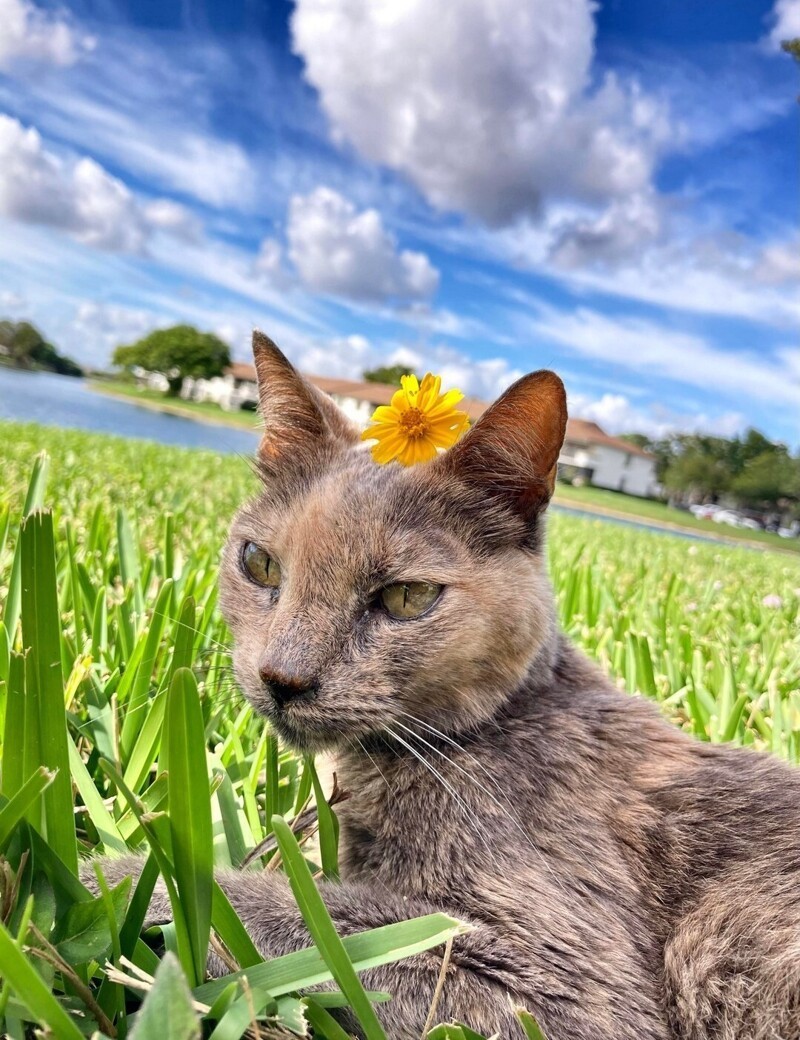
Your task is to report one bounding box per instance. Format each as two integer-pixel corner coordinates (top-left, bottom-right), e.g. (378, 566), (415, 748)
(0, 365), (258, 454)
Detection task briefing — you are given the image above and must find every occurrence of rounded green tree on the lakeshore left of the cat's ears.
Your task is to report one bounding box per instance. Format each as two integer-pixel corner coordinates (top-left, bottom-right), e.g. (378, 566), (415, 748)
(112, 326), (231, 397)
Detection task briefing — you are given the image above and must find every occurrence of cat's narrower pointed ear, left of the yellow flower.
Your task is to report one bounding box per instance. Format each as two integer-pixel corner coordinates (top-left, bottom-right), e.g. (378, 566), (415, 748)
(253, 330), (359, 465)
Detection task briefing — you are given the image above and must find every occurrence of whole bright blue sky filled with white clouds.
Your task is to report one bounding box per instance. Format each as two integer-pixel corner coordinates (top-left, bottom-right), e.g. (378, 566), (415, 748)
(0, 0), (800, 445)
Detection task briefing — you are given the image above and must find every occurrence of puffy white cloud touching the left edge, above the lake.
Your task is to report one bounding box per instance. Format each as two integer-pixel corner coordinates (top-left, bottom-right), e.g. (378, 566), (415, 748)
(0, 113), (209, 253)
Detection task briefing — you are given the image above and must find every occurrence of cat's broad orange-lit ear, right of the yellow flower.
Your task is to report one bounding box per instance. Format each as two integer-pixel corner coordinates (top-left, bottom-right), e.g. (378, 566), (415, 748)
(434, 369), (567, 523)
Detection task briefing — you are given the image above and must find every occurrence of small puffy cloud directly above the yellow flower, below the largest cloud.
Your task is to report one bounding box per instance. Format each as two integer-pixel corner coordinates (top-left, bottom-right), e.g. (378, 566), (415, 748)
(286, 187), (439, 302)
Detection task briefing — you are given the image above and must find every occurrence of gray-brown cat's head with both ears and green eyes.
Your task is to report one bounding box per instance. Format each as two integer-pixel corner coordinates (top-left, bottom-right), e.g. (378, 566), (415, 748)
(221, 333), (567, 750)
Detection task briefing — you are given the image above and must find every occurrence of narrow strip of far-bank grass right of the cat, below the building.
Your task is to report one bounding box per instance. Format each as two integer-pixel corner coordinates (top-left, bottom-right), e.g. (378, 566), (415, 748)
(556, 484), (800, 553)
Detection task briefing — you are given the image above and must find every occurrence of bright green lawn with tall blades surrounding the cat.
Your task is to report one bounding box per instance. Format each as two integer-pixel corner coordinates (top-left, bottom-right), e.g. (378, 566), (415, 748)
(0, 423), (800, 1040)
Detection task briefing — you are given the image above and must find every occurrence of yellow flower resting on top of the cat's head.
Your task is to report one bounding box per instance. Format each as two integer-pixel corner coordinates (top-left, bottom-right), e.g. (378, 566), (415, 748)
(361, 372), (469, 466)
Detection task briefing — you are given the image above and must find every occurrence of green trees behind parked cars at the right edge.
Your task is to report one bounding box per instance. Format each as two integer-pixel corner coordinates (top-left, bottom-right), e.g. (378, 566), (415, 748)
(625, 430), (800, 515)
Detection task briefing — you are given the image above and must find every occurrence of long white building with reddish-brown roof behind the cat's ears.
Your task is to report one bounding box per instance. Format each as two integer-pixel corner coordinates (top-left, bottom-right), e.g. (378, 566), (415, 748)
(181, 362), (657, 498)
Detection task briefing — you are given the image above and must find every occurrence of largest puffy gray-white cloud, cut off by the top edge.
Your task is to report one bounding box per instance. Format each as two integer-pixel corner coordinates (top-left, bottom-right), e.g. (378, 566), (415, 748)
(292, 0), (674, 225)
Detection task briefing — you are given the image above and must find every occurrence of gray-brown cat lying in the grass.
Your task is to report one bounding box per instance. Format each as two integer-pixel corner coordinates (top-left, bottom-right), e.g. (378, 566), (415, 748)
(90, 334), (800, 1040)
